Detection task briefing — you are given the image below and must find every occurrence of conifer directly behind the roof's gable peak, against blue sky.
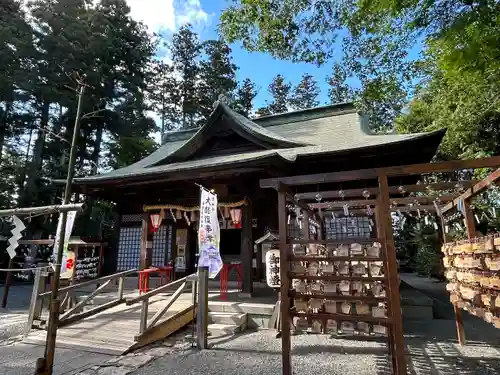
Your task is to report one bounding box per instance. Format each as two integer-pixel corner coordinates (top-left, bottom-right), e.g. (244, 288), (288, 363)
(198, 40), (237, 123)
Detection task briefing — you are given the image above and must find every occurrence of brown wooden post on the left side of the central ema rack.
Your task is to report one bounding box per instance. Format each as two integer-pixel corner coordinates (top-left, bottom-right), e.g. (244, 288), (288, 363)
(278, 190), (292, 375)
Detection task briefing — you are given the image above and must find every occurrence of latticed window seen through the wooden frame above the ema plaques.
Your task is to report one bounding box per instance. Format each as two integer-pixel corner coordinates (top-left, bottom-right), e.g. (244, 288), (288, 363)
(325, 215), (371, 240)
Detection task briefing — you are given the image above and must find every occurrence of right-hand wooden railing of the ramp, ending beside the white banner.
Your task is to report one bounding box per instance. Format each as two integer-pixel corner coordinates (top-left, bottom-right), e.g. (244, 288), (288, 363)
(126, 274), (198, 336)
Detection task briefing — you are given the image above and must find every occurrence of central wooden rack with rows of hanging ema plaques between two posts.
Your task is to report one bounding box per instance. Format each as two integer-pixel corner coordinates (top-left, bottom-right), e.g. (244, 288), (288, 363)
(276, 192), (406, 375)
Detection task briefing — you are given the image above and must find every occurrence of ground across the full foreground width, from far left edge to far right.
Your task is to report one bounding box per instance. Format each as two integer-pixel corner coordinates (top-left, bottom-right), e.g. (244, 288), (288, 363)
(0, 275), (500, 375)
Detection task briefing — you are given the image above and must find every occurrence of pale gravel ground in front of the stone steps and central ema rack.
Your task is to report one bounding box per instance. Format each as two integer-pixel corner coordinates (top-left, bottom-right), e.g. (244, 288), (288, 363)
(131, 320), (500, 375)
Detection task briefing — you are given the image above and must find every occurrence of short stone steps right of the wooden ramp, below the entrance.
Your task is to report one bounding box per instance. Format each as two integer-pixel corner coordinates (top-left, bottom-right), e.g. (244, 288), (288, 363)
(208, 303), (248, 337)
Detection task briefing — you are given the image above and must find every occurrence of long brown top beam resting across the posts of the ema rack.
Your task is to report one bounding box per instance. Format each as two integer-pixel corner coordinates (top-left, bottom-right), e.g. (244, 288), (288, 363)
(260, 156), (500, 188)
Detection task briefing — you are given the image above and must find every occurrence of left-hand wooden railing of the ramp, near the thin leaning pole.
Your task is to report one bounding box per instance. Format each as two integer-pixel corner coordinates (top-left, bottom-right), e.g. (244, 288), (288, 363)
(25, 269), (137, 334)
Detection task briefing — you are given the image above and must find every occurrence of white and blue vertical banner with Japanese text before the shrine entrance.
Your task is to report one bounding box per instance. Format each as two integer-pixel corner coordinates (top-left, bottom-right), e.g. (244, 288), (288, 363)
(198, 189), (222, 279)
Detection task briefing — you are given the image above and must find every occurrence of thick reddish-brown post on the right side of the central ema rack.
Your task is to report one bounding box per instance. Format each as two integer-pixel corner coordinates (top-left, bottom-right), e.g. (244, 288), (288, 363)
(378, 173), (407, 375)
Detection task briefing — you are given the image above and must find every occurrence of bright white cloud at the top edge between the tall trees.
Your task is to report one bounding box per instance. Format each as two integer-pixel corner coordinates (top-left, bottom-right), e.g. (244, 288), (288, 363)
(127, 0), (211, 33)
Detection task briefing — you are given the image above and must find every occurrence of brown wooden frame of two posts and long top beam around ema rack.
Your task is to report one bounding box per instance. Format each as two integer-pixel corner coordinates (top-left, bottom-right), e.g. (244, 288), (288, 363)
(260, 156), (500, 375)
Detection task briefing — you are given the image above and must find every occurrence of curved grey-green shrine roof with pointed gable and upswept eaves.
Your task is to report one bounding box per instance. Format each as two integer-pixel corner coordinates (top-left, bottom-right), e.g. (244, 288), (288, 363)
(71, 102), (445, 185)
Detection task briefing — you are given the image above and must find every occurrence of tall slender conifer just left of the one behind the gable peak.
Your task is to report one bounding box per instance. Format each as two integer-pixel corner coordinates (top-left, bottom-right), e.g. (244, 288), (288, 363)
(170, 24), (202, 128)
